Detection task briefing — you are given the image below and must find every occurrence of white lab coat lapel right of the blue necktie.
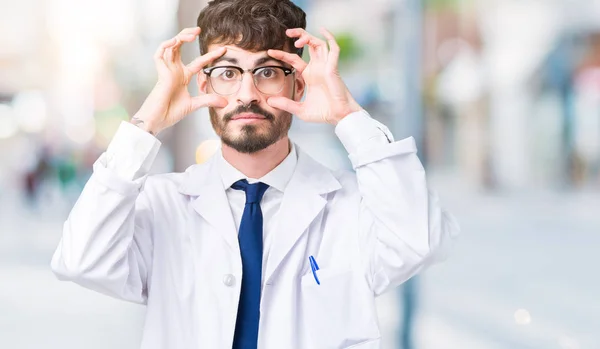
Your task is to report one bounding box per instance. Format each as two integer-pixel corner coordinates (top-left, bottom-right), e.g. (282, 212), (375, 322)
(264, 146), (341, 283)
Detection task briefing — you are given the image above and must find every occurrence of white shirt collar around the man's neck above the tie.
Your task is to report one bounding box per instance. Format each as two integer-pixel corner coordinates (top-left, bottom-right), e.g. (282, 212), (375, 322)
(217, 142), (298, 192)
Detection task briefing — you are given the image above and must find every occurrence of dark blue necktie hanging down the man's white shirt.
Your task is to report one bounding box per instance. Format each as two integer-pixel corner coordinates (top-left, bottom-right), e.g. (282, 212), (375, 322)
(231, 179), (269, 349)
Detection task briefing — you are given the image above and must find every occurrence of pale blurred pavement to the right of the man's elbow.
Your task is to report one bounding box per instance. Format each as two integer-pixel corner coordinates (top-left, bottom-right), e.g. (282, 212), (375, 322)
(419, 181), (600, 349)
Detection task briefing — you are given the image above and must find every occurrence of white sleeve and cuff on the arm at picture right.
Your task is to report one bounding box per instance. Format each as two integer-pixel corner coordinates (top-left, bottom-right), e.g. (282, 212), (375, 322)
(336, 111), (460, 294)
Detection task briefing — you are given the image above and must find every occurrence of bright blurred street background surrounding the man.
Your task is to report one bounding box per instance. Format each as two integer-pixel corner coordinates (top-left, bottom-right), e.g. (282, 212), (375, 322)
(0, 0), (600, 349)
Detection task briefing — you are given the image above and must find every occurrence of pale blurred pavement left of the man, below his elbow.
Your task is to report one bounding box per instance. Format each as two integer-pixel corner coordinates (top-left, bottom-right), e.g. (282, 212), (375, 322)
(0, 188), (143, 349)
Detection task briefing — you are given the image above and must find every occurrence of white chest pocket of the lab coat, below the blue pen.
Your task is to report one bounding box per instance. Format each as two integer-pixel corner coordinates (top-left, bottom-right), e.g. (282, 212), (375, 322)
(301, 268), (380, 349)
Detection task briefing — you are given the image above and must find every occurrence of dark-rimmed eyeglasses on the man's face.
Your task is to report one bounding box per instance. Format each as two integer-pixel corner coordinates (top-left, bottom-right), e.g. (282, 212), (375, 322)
(203, 66), (296, 96)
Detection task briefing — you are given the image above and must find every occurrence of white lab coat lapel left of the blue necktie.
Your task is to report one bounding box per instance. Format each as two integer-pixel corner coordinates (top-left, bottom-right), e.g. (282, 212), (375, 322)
(179, 156), (240, 255)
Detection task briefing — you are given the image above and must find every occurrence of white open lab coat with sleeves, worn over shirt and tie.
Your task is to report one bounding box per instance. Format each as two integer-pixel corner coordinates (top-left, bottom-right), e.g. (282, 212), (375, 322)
(52, 116), (458, 349)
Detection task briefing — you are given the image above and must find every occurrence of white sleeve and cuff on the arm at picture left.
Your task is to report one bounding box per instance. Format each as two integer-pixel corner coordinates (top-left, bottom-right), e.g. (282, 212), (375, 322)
(51, 123), (160, 303)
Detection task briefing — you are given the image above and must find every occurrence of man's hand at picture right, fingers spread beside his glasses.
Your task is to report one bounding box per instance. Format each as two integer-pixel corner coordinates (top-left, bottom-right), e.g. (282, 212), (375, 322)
(267, 28), (361, 125)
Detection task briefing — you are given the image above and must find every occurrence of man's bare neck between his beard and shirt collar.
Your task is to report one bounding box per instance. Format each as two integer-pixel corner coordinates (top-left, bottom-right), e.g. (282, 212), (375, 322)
(221, 136), (290, 179)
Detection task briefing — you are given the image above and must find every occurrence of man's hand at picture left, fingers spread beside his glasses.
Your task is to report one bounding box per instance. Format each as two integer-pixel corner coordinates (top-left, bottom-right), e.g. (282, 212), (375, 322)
(132, 27), (227, 135)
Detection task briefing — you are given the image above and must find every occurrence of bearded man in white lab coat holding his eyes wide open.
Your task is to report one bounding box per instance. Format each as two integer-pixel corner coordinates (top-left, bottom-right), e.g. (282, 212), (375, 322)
(52, 0), (458, 349)
